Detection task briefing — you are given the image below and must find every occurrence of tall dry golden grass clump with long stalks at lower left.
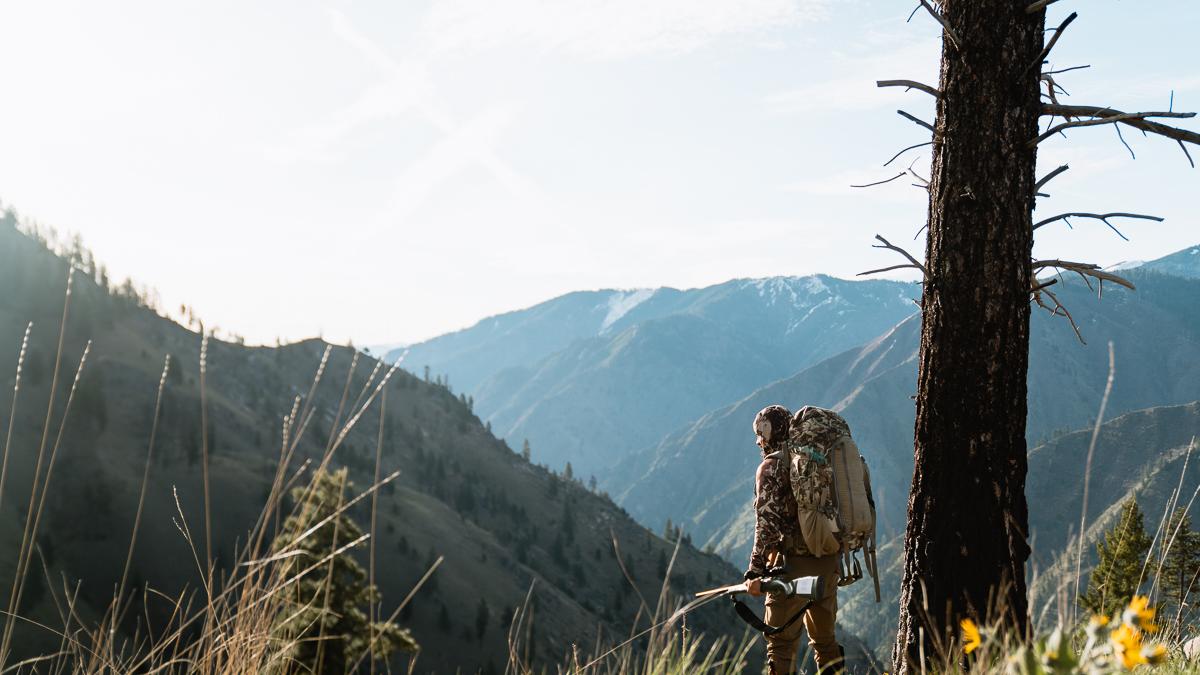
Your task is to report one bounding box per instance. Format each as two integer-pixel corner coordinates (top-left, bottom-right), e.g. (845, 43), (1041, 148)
(0, 270), (440, 675)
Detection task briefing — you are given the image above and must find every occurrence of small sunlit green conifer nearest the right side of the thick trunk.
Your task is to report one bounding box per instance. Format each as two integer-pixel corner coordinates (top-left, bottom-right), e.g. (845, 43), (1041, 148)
(1080, 497), (1152, 616)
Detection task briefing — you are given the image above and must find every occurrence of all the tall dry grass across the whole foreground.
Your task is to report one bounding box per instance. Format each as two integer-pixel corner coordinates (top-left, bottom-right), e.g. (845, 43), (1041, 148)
(0, 270), (1200, 675)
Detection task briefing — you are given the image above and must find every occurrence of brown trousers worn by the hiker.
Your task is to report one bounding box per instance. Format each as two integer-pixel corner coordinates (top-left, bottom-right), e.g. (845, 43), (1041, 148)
(766, 554), (841, 675)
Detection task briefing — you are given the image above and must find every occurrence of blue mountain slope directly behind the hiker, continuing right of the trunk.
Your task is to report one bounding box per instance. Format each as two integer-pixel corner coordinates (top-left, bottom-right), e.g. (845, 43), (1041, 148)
(604, 270), (1200, 560)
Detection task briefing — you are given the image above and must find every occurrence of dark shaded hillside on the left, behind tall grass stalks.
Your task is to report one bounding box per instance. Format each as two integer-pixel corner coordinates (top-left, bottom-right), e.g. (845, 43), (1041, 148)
(0, 215), (742, 673)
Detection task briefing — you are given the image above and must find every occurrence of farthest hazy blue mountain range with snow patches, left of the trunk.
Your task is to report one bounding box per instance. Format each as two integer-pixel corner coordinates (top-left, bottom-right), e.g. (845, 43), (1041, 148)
(385, 276), (919, 476)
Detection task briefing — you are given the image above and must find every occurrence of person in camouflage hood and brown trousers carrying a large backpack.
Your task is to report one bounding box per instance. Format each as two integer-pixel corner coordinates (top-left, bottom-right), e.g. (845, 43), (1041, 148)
(745, 406), (878, 675)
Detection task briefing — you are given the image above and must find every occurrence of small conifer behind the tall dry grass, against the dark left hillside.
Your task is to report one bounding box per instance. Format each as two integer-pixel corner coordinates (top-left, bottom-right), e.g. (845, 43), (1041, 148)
(272, 468), (418, 675)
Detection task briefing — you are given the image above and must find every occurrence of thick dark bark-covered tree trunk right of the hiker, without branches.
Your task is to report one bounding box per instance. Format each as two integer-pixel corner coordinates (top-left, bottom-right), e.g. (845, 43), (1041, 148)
(892, 0), (1045, 673)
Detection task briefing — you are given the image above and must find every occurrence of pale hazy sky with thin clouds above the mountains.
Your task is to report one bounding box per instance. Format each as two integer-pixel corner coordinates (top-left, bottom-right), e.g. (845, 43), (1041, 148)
(0, 0), (1200, 344)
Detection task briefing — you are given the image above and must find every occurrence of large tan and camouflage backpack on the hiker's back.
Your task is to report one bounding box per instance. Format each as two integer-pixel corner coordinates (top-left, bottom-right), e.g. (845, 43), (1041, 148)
(786, 406), (880, 602)
